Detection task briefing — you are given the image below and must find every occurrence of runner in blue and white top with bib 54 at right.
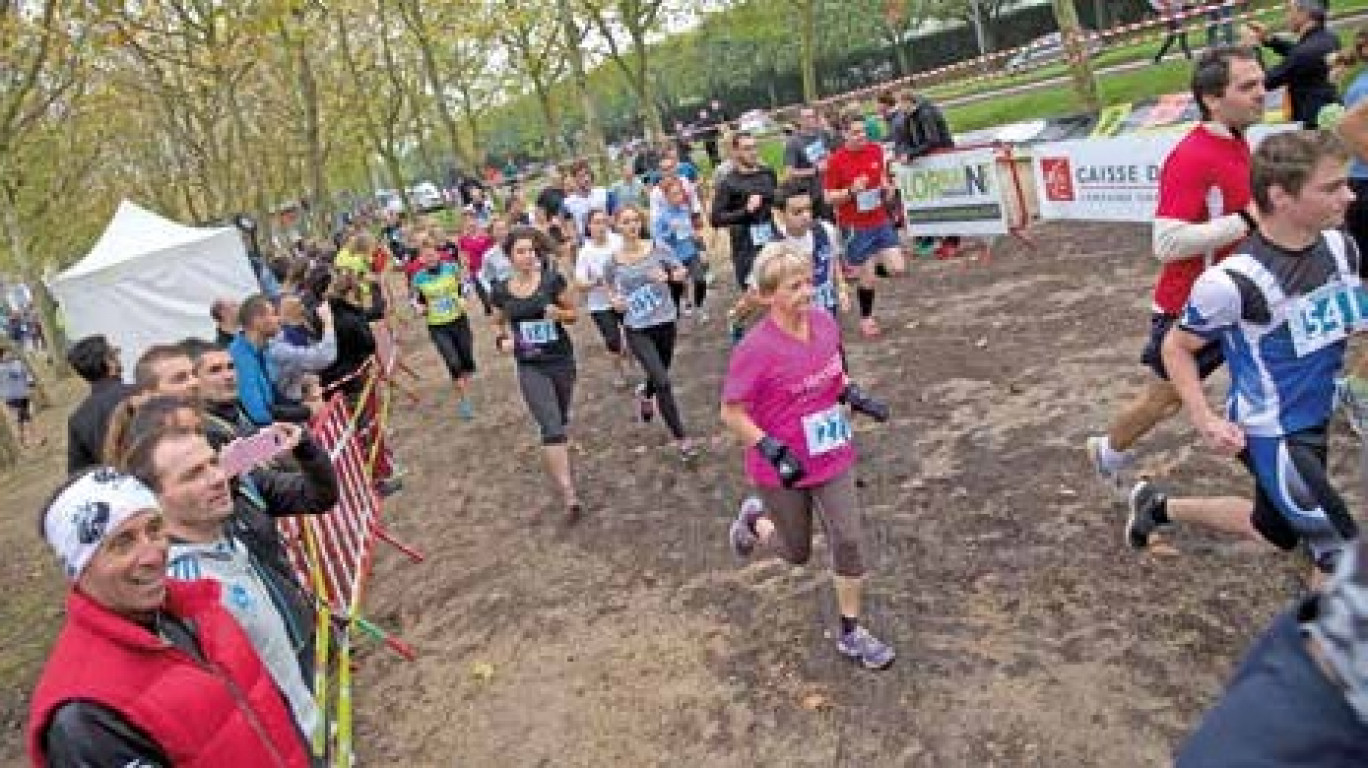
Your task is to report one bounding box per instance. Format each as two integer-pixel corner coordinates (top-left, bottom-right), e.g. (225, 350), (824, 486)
(1126, 131), (1368, 572)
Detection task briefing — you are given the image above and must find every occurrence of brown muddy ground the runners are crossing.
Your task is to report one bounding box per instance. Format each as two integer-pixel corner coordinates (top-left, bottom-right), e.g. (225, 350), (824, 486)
(0, 219), (1356, 768)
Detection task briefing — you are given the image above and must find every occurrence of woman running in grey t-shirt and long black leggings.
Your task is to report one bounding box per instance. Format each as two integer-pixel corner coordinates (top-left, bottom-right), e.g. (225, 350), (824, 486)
(603, 205), (702, 461)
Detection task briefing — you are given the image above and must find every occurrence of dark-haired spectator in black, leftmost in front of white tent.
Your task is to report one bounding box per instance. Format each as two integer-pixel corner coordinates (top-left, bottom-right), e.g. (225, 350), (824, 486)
(67, 334), (129, 474)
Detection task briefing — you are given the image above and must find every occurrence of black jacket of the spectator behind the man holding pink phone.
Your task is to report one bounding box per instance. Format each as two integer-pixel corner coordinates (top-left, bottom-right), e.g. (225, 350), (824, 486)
(227, 437), (338, 680)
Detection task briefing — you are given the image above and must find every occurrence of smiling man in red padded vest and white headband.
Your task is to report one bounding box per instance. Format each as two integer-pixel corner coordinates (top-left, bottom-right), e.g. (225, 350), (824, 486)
(29, 467), (309, 768)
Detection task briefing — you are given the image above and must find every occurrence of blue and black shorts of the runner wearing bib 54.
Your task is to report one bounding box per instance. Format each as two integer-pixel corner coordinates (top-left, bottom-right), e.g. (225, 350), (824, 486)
(1239, 426), (1357, 568)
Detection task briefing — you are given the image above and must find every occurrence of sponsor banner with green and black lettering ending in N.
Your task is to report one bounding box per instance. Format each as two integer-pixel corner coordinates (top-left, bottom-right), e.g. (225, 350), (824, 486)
(893, 149), (1008, 237)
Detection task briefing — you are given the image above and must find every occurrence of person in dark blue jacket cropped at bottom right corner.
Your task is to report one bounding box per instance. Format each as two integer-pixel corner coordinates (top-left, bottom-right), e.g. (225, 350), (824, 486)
(1176, 541), (1368, 768)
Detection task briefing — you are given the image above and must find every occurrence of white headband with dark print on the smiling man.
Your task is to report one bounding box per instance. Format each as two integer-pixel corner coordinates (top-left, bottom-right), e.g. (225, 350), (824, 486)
(42, 467), (161, 582)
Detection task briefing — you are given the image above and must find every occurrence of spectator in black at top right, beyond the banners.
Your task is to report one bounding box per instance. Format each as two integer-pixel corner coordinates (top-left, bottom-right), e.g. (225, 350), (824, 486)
(1245, 0), (1339, 129)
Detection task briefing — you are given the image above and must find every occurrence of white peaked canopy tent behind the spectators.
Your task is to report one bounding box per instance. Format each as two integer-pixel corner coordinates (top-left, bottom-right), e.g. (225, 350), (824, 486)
(51, 200), (261, 376)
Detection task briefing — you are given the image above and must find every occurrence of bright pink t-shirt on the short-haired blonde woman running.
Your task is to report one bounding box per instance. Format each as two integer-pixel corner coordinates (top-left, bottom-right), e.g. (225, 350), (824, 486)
(722, 307), (855, 487)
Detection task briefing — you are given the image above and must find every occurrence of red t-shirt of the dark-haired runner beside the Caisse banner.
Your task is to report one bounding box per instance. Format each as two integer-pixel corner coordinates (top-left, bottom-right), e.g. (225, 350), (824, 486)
(1155, 126), (1252, 315)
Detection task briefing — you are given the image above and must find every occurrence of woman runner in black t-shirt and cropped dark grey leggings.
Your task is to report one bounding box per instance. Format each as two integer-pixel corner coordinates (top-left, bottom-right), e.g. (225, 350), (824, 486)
(490, 227), (583, 523)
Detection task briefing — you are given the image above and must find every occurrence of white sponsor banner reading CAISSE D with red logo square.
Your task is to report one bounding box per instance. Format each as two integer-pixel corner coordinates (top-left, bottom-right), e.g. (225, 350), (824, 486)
(1030, 123), (1298, 222)
